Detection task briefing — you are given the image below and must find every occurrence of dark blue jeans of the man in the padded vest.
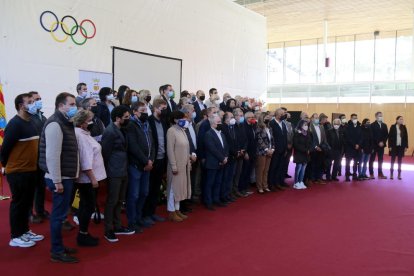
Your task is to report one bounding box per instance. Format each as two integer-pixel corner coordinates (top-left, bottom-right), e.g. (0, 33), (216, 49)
(45, 178), (74, 254)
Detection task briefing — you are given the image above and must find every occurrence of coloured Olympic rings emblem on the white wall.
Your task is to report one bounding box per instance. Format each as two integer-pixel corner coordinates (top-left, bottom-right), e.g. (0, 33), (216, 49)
(40, 11), (96, 45)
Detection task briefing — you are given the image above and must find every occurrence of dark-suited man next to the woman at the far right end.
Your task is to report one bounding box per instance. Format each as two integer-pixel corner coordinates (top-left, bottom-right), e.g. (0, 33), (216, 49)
(369, 112), (388, 179)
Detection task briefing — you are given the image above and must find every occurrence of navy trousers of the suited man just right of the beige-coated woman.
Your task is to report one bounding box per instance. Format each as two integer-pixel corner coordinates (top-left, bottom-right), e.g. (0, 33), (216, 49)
(203, 168), (224, 206)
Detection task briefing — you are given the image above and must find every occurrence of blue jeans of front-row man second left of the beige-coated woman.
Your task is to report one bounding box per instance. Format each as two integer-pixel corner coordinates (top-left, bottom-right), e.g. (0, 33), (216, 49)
(126, 165), (149, 226)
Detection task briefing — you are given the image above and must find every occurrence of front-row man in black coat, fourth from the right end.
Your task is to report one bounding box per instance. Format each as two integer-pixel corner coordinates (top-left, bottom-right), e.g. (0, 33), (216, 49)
(345, 114), (362, 182)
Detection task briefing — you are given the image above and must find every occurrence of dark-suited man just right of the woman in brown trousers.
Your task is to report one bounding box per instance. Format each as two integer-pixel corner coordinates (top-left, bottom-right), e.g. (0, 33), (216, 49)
(267, 108), (288, 191)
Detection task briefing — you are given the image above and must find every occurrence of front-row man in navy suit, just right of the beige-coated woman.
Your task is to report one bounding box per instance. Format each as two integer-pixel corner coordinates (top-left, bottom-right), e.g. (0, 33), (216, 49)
(203, 114), (229, 211)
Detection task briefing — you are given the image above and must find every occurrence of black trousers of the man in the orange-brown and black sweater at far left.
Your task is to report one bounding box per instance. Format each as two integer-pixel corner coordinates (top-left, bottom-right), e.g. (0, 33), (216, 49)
(6, 172), (36, 239)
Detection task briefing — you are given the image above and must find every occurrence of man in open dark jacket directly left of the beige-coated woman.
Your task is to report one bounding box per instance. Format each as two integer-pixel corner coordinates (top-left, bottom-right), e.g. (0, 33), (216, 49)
(142, 99), (167, 225)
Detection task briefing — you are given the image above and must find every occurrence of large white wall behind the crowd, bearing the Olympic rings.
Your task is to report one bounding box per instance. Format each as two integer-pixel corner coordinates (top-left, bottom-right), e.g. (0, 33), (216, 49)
(0, 0), (266, 119)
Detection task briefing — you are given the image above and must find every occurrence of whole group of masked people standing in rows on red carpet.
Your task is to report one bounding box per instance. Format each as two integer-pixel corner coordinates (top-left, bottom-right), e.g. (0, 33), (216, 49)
(1, 83), (408, 263)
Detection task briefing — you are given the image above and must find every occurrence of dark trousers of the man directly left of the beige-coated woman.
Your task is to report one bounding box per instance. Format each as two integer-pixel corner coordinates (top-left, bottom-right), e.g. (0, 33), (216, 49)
(142, 158), (167, 217)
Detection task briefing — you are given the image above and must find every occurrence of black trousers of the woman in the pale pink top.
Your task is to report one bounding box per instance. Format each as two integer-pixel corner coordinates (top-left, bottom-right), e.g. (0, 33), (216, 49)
(78, 183), (96, 233)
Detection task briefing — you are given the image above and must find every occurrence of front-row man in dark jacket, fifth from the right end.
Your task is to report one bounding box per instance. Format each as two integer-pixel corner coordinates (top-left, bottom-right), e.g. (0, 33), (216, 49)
(326, 119), (344, 181)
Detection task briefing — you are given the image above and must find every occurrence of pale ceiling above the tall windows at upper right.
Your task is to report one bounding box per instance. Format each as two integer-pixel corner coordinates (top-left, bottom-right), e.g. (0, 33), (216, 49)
(235, 0), (414, 43)
